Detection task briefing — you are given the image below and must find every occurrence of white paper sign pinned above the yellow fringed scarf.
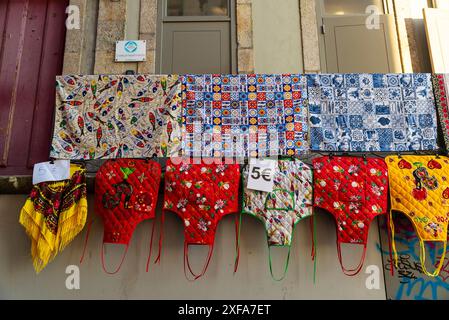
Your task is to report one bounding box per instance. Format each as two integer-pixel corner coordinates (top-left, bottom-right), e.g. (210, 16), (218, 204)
(33, 160), (70, 184)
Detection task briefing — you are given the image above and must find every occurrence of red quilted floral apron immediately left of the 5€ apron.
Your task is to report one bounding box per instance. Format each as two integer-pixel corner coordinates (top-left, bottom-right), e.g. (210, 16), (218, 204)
(164, 158), (240, 280)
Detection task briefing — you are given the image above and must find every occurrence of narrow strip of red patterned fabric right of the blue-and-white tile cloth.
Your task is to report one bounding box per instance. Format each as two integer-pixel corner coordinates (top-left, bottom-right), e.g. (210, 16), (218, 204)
(432, 74), (449, 152)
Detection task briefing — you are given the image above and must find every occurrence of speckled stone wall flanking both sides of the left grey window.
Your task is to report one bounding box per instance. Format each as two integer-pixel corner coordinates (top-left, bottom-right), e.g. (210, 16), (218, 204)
(63, 0), (254, 74)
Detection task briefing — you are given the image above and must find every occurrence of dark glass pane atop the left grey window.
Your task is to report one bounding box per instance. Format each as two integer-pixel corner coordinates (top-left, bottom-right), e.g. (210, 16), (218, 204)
(167, 0), (229, 17)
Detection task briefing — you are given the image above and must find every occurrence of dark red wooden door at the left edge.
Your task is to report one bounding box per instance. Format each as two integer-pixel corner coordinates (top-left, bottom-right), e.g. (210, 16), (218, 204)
(0, 0), (69, 175)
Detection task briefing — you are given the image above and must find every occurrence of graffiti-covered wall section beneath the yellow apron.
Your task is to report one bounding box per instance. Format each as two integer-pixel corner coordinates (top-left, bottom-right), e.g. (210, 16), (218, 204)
(378, 214), (449, 300)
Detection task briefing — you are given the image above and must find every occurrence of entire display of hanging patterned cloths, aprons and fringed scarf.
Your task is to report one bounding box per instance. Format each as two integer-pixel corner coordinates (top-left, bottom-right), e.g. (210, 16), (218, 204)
(19, 69), (449, 280)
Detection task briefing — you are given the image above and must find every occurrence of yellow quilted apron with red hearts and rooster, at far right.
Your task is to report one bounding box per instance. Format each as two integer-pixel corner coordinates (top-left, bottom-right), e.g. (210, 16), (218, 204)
(385, 156), (449, 277)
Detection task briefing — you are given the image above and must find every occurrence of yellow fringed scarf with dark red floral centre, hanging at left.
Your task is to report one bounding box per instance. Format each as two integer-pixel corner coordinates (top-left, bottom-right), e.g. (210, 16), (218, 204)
(19, 164), (87, 273)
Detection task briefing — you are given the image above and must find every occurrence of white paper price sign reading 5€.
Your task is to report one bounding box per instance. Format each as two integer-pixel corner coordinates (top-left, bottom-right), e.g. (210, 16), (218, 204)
(247, 158), (276, 192)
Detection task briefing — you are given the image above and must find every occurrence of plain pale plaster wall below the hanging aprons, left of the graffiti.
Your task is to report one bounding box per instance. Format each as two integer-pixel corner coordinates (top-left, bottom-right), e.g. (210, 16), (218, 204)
(0, 195), (385, 299)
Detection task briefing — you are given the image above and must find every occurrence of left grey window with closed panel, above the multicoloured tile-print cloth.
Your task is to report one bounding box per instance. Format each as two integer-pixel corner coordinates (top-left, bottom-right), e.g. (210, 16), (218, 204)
(156, 0), (236, 74)
